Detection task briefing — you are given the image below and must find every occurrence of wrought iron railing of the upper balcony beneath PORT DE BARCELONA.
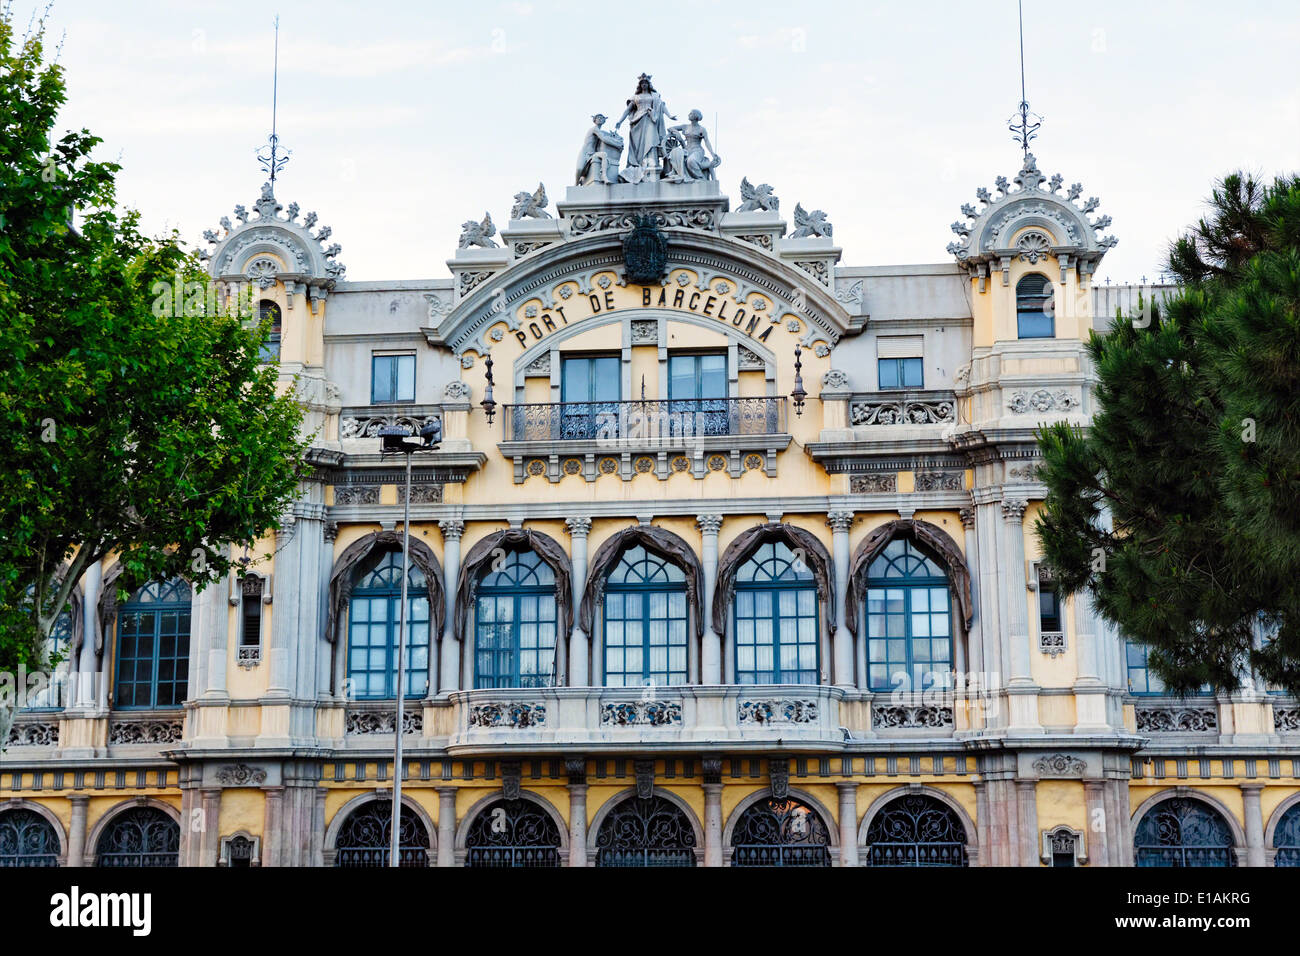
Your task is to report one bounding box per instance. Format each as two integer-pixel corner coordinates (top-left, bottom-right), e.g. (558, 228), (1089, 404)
(506, 395), (785, 441)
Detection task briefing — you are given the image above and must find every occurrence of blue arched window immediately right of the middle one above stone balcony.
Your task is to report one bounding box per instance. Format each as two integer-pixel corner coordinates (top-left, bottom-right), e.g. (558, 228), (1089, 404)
(732, 541), (819, 684)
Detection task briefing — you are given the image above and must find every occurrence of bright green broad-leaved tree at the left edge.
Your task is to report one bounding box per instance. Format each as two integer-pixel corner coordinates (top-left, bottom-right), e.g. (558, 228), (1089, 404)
(0, 8), (306, 723)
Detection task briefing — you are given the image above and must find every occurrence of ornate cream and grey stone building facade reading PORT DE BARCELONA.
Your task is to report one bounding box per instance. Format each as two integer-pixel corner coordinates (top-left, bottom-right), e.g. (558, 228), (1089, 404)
(0, 77), (1300, 866)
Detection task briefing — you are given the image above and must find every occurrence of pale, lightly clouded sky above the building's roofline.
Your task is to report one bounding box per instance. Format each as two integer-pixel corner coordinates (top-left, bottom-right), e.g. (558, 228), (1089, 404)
(14, 0), (1300, 282)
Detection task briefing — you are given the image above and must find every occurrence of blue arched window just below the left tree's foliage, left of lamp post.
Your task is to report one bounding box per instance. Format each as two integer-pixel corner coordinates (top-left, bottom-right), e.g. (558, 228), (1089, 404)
(113, 578), (190, 709)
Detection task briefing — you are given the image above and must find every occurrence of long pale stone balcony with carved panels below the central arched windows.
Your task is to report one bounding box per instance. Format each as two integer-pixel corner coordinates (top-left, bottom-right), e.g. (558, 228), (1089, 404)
(447, 684), (845, 753)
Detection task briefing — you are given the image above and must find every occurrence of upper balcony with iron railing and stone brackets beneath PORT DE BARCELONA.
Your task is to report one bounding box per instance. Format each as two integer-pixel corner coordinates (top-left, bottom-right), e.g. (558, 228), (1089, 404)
(499, 395), (790, 484)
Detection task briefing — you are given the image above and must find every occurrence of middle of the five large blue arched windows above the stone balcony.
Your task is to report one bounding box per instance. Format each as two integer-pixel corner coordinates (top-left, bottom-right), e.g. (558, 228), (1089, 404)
(605, 545), (686, 687)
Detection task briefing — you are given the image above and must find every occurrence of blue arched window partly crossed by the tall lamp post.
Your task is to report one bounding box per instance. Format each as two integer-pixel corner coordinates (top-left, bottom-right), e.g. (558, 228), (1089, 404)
(347, 551), (429, 700)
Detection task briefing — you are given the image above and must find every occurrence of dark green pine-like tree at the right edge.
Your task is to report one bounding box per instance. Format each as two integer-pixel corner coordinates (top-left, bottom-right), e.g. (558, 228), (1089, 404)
(1037, 174), (1300, 693)
